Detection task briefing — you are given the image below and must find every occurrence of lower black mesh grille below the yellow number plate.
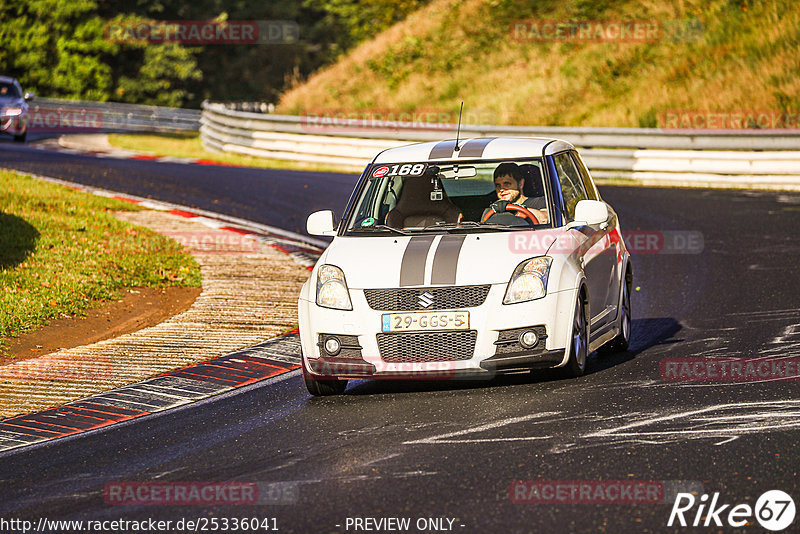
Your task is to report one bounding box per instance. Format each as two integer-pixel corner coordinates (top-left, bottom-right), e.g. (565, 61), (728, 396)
(377, 330), (478, 363)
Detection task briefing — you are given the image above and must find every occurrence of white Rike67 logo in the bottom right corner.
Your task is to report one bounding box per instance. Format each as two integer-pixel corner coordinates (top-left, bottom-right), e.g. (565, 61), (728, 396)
(667, 490), (795, 532)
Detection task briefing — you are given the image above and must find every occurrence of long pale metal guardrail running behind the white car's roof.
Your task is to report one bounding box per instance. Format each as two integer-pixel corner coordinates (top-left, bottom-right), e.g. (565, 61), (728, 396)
(200, 103), (800, 189)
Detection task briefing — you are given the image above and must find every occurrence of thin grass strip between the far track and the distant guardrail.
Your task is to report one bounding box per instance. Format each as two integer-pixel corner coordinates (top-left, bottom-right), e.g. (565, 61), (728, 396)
(108, 132), (356, 172)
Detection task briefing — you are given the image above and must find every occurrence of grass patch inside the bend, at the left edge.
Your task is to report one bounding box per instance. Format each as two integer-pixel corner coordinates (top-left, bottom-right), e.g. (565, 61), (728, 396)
(0, 170), (200, 356)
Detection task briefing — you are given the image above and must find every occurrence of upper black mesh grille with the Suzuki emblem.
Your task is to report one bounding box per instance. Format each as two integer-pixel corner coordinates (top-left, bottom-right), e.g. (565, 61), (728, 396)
(364, 285), (491, 311)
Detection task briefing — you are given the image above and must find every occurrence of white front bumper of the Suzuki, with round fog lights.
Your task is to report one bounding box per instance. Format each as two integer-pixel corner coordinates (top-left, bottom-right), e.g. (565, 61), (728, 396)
(299, 284), (575, 380)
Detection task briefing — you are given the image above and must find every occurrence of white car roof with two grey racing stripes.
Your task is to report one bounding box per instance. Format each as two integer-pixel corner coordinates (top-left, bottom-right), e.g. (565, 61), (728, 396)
(375, 137), (575, 163)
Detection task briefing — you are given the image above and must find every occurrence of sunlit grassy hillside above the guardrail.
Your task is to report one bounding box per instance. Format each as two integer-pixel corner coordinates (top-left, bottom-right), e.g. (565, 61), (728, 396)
(278, 0), (800, 127)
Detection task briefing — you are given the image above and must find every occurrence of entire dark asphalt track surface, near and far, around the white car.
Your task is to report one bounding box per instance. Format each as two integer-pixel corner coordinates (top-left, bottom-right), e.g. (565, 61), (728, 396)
(0, 143), (800, 532)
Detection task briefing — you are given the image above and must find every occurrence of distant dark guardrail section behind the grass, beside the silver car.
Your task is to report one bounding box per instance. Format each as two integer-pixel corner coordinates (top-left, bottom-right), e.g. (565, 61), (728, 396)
(34, 98), (201, 132)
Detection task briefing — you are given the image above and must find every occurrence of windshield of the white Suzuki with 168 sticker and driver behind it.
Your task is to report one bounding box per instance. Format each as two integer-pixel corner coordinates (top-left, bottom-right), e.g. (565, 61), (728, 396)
(346, 158), (550, 235)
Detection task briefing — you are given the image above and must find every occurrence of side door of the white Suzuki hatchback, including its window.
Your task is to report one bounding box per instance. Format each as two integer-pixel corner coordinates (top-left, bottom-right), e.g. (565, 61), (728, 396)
(553, 152), (616, 329)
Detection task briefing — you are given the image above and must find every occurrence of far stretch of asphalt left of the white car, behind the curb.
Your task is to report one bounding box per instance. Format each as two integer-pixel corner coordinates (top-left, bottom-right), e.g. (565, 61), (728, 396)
(0, 140), (358, 234)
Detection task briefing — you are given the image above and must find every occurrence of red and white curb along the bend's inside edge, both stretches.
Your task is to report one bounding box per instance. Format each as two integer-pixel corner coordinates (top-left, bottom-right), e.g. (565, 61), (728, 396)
(0, 169), (326, 453)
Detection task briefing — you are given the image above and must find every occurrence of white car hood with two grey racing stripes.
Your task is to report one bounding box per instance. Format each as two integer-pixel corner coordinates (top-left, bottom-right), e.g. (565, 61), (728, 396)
(320, 230), (574, 289)
